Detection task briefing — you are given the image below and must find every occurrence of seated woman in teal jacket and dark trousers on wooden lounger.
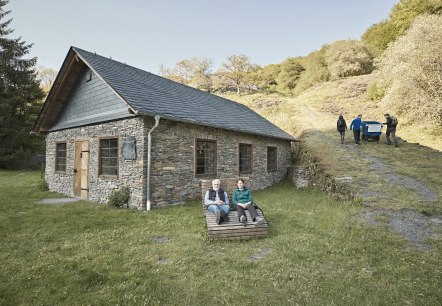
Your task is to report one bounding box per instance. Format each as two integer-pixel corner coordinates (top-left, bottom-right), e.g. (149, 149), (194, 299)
(232, 178), (264, 226)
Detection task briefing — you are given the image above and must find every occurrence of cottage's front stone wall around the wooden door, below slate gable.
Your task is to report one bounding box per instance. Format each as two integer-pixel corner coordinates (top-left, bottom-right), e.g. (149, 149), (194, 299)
(45, 117), (146, 206)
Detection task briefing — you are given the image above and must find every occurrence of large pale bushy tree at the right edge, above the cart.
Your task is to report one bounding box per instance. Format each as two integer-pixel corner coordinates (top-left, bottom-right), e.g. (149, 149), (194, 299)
(378, 15), (442, 127)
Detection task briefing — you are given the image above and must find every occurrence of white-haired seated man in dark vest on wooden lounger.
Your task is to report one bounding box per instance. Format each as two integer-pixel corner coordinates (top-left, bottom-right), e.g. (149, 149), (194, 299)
(204, 179), (230, 224)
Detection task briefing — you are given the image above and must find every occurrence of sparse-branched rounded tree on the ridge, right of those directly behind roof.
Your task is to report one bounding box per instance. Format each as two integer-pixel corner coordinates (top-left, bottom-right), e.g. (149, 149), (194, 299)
(216, 54), (257, 96)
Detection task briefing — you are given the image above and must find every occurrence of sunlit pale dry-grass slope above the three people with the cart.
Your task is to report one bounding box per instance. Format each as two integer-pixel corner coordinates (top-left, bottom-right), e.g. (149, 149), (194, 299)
(227, 74), (442, 151)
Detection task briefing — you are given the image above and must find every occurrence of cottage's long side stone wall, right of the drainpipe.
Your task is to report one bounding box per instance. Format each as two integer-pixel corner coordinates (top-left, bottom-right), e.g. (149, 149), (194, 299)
(151, 120), (291, 206)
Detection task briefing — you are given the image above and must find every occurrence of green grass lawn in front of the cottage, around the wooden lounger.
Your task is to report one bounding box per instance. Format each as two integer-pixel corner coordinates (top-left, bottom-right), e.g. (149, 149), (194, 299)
(0, 171), (442, 305)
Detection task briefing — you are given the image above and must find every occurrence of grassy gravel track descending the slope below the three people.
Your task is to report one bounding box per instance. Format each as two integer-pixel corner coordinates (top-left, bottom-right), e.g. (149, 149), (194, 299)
(292, 100), (442, 251)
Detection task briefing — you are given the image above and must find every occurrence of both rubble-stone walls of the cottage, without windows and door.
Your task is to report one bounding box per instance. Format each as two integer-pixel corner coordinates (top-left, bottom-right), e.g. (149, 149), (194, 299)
(46, 116), (291, 207)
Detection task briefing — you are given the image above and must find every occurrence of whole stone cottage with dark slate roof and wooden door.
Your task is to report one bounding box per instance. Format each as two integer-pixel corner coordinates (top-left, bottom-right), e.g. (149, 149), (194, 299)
(33, 47), (295, 209)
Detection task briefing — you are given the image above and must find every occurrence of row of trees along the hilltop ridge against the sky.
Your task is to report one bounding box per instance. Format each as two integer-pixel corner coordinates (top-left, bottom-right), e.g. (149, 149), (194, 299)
(160, 0), (442, 96)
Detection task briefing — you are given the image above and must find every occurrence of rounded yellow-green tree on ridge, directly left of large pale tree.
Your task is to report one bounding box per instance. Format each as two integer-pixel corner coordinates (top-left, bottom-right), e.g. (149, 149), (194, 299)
(325, 40), (373, 79)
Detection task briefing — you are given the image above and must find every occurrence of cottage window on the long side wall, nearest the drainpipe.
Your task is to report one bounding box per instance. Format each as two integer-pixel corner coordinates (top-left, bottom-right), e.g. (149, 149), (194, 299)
(195, 139), (216, 175)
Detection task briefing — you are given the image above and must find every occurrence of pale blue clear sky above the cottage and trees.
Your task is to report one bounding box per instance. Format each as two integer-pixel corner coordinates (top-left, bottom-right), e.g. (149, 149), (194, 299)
(2, 0), (399, 73)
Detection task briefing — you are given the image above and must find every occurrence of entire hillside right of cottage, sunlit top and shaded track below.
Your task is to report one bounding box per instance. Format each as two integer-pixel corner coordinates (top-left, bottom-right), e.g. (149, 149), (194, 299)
(223, 75), (442, 249)
